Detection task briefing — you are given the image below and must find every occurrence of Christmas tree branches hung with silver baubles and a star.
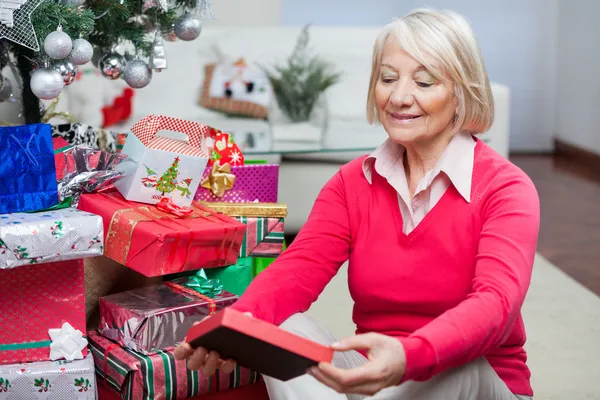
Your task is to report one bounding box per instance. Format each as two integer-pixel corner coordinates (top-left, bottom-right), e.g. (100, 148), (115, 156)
(0, 0), (214, 123)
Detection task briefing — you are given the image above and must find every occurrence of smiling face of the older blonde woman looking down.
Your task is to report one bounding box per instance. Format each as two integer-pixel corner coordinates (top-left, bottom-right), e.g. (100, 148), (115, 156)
(375, 38), (457, 145)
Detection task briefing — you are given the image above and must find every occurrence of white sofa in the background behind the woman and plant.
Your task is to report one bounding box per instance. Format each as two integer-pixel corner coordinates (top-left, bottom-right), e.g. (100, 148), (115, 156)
(54, 26), (509, 233)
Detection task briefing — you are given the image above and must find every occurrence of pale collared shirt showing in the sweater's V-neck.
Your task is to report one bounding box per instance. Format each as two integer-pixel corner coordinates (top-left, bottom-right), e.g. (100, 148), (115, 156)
(362, 132), (477, 234)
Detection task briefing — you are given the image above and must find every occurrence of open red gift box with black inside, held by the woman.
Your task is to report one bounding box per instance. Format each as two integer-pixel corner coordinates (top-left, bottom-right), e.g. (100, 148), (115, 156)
(186, 308), (333, 381)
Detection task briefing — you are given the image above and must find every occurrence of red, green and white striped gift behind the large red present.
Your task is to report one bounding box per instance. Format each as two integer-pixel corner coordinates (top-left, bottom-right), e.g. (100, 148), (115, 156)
(235, 217), (284, 257)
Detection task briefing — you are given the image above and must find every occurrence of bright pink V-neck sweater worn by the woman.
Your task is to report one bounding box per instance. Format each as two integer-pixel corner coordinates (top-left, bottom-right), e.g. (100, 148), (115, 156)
(233, 141), (539, 396)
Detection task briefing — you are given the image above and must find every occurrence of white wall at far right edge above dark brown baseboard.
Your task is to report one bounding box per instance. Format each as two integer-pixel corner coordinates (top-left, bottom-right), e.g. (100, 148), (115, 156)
(556, 0), (600, 154)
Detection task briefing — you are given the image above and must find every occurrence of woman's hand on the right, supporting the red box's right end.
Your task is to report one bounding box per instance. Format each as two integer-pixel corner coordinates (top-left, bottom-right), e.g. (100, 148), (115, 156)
(308, 333), (406, 396)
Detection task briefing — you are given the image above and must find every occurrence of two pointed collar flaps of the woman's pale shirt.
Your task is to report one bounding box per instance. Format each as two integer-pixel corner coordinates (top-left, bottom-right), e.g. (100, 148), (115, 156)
(362, 132), (477, 202)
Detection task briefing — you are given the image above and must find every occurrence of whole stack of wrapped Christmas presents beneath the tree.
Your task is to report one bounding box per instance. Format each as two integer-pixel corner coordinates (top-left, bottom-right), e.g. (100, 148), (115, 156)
(0, 115), (287, 400)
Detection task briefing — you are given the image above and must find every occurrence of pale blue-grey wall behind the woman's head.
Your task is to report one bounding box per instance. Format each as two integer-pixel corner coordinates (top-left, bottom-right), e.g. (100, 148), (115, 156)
(282, 0), (556, 151)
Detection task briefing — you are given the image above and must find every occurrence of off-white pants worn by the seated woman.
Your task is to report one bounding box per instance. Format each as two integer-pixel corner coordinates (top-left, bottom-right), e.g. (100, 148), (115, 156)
(264, 314), (530, 400)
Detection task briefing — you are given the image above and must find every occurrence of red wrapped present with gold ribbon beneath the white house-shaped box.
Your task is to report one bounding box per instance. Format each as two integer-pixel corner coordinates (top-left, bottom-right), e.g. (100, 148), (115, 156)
(79, 190), (246, 276)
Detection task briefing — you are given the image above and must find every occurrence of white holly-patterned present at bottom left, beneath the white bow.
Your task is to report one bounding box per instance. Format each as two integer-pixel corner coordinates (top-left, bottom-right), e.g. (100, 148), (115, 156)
(0, 354), (98, 400)
